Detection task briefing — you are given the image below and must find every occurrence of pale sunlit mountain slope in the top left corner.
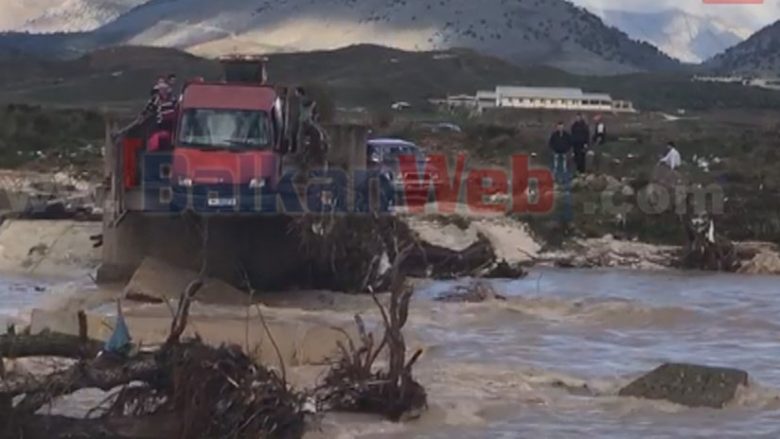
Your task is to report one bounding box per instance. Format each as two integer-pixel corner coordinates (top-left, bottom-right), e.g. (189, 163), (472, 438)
(0, 0), (147, 33)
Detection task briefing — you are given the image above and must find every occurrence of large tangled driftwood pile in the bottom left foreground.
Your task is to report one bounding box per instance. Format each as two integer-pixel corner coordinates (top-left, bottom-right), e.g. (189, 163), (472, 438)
(0, 281), (304, 438)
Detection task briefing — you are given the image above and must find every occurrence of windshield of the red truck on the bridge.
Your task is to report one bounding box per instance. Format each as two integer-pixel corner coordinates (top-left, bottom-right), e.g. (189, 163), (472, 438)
(178, 108), (273, 150)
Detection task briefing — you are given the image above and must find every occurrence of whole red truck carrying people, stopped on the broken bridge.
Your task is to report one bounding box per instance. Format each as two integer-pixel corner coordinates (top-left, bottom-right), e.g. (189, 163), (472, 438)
(115, 58), (314, 213)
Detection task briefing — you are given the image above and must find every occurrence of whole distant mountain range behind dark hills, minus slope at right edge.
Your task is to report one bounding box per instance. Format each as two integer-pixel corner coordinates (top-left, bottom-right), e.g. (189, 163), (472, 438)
(0, 0), (776, 75)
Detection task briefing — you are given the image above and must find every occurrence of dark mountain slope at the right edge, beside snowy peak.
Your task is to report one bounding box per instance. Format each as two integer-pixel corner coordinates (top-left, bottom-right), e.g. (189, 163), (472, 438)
(705, 21), (780, 76)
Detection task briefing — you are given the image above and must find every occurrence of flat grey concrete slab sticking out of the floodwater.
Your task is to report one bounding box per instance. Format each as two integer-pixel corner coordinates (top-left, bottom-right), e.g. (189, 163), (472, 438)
(619, 363), (748, 408)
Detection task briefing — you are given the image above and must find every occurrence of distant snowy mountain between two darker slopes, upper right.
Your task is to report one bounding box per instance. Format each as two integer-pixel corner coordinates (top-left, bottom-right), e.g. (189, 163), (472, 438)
(601, 9), (750, 63)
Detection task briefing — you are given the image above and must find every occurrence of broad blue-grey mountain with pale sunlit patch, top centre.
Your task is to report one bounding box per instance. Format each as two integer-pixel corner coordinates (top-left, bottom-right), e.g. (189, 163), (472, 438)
(0, 0), (678, 74)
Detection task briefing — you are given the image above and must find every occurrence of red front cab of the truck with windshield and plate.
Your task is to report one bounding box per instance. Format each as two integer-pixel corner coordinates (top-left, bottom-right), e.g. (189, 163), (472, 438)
(170, 82), (285, 211)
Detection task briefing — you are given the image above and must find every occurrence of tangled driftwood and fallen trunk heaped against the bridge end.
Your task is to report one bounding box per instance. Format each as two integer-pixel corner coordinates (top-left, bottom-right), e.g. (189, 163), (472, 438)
(292, 215), (527, 293)
